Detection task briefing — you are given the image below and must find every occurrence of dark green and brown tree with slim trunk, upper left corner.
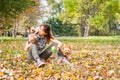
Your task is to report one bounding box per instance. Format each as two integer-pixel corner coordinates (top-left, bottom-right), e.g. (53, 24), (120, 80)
(0, 0), (36, 37)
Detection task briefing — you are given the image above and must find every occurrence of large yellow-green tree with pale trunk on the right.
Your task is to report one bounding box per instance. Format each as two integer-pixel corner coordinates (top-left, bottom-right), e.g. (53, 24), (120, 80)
(60, 0), (120, 37)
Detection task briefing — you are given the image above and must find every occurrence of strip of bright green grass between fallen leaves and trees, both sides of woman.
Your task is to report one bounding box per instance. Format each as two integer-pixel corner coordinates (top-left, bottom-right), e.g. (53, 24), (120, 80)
(0, 36), (120, 44)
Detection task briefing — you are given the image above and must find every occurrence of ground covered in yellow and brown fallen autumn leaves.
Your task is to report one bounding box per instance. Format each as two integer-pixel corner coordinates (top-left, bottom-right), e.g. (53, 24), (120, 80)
(0, 41), (120, 80)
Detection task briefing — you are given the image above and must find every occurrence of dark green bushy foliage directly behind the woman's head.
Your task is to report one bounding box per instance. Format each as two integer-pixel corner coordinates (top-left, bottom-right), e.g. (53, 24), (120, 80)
(46, 18), (78, 36)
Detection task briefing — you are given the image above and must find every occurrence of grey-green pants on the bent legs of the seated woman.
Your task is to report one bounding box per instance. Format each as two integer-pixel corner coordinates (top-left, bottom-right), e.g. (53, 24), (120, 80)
(27, 44), (64, 61)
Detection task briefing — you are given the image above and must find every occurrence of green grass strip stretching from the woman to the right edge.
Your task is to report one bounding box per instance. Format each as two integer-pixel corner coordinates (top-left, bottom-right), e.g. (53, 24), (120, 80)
(58, 36), (120, 44)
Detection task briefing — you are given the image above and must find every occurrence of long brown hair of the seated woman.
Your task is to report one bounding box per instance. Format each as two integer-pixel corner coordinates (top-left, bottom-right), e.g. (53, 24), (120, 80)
(41, 24), (54, 43)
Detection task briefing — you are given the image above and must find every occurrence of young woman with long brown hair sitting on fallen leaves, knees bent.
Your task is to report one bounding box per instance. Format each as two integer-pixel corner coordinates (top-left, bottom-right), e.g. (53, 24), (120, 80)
(25, 24), (70, 67)
